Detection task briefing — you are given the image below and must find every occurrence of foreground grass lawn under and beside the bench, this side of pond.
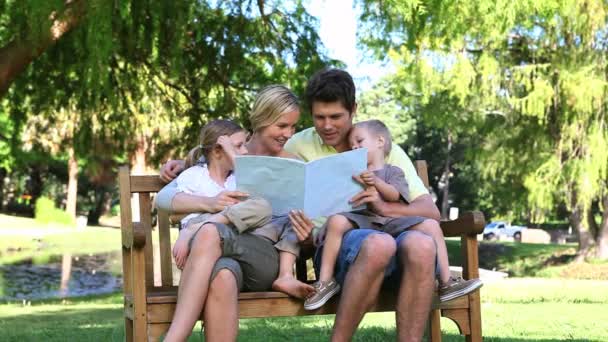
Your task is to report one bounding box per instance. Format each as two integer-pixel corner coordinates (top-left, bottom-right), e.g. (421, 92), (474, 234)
(0, 278), (608, 342)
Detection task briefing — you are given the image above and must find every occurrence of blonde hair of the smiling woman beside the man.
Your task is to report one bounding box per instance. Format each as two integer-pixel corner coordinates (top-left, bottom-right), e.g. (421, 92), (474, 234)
(249, 84), (300, 132)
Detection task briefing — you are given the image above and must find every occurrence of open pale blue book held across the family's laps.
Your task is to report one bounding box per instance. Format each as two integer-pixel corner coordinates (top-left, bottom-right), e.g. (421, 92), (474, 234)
(235, 148), (367, 219)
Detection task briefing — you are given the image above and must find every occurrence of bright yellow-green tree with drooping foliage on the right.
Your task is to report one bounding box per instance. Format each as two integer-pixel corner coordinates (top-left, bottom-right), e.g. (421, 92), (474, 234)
(362, 0), (608, 259)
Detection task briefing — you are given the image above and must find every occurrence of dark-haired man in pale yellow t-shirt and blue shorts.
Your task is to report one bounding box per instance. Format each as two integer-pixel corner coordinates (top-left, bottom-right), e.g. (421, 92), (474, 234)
(161, 69), (440, 341)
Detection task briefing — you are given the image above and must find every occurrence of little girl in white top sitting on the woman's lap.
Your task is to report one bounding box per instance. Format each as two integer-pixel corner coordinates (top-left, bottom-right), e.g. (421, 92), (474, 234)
(173, 120), (312, 297)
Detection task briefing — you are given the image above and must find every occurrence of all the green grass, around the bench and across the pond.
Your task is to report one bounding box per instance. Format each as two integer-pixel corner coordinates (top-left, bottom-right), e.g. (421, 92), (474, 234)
(0, 215), (608, 342)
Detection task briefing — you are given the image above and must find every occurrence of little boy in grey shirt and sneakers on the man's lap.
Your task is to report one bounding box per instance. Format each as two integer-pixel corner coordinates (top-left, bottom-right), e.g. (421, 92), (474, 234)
(304, 120), (482, 310)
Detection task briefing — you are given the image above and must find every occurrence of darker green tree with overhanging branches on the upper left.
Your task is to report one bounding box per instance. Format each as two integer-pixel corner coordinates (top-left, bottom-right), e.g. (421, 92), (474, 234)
(0, 0), (336, 216)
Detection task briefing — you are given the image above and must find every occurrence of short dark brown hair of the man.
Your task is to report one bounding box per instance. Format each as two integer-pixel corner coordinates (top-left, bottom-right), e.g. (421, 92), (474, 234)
(305, 68), (356, 113)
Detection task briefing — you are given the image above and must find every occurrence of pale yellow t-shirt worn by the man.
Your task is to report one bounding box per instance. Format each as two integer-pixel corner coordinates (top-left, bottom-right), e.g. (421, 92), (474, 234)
(285, 127), (429, 244)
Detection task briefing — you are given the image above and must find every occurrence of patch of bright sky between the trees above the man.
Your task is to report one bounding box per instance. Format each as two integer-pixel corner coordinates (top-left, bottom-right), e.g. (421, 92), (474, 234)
(305, 0), (391, 90)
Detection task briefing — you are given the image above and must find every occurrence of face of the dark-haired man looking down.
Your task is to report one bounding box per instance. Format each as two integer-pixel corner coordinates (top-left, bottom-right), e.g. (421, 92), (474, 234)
(311, 101), (356, 152)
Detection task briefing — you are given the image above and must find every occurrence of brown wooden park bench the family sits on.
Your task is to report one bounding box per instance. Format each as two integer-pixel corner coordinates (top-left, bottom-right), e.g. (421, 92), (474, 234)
(119, 161), (485, 342)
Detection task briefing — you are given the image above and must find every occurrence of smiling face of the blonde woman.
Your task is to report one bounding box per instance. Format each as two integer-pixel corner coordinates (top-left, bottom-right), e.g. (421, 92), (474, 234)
(257, 110), (300, 155)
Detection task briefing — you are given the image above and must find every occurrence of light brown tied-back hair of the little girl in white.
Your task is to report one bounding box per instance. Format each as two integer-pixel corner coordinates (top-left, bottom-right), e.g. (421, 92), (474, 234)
(186, 120), (245, 168)
